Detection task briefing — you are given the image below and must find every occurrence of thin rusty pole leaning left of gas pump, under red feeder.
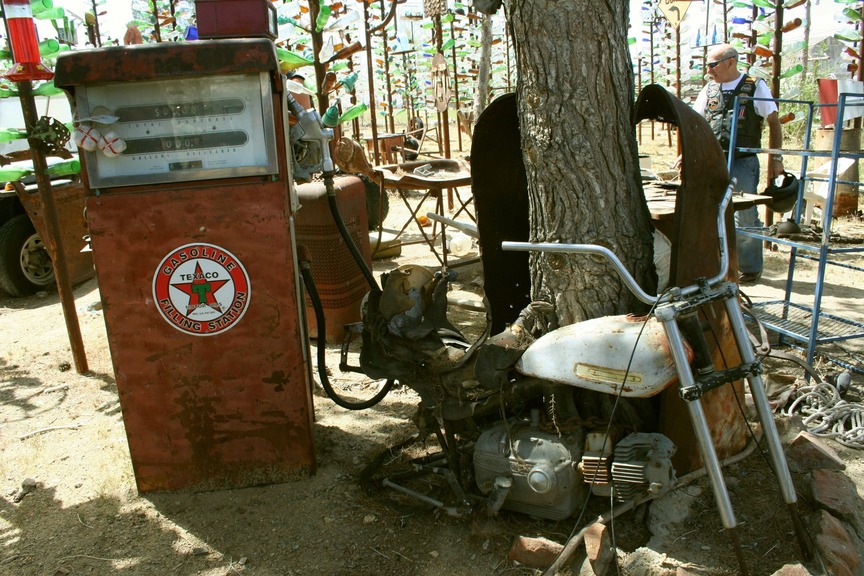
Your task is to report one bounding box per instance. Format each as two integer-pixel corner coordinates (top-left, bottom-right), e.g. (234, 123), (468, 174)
(18, 81), (89, 374)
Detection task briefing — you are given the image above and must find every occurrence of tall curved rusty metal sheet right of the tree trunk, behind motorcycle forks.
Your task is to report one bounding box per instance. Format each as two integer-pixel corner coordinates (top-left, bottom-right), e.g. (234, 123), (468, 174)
(634, 84), (747, 474)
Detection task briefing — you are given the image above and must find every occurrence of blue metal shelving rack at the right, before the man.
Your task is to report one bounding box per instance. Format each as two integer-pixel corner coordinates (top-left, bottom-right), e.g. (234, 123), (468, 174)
(729, 94), (864, 372)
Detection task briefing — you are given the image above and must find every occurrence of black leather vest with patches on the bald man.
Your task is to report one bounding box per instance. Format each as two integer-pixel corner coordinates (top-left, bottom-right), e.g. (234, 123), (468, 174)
(705, 74), (762, 158)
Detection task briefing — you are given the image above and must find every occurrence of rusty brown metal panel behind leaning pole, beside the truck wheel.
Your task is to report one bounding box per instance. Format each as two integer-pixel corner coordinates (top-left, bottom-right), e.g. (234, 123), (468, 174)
(15, 181), (95, 284)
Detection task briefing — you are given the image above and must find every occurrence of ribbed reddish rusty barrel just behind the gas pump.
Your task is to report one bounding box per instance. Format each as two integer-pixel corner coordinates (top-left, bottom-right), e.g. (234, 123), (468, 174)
(296, 176), (372, 343)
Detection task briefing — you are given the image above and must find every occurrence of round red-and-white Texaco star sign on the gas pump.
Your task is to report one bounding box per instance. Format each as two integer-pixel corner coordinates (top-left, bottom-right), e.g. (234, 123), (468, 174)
(153, 243), (251, 336)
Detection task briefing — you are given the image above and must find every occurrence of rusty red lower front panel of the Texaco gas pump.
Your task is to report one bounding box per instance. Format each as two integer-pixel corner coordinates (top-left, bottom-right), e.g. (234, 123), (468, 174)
(87, 181), (315, 492)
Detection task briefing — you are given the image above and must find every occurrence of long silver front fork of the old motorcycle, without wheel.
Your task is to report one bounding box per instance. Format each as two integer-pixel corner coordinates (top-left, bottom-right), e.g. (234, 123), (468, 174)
(655, 282), (811, 576)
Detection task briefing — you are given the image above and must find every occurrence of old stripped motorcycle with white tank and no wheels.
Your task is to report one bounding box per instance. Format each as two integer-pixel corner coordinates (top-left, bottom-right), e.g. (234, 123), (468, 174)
(286, 92), (809, 574)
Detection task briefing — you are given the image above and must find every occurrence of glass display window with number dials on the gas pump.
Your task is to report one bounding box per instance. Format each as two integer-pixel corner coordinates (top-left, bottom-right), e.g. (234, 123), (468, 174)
(76, 73), (278, 188)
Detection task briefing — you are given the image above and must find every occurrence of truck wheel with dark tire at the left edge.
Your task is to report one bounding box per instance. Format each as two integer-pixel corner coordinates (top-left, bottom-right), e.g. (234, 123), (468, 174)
(0, 214), (54, 298)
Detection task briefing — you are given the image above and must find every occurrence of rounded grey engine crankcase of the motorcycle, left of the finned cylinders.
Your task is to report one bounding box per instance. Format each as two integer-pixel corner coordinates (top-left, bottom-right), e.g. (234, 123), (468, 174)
(474, 422), (587, 520)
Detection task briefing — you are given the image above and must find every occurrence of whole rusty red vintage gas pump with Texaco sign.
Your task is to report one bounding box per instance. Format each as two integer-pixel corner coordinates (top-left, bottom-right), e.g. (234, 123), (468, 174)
(55, 39), (315, 492)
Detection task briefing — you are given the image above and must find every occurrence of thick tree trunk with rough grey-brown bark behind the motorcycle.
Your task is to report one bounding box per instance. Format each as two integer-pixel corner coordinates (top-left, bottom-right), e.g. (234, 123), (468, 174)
(507, 0), (656, 325)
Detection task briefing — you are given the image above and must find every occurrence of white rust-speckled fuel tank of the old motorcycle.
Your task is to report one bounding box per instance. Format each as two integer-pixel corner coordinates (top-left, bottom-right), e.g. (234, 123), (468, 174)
(516, 315), (693, 398)
